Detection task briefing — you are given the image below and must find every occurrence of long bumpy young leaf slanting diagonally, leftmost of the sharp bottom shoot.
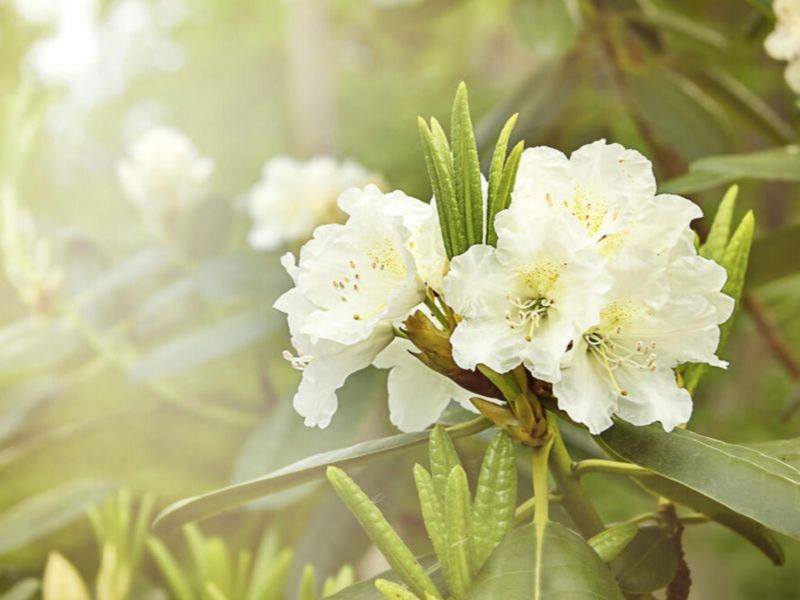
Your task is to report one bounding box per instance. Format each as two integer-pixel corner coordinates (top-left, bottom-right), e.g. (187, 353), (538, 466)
(328, 467), (440, 598)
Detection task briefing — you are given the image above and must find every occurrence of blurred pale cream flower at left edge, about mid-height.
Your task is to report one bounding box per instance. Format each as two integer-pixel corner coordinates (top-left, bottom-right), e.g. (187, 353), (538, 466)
(2, 189), (64, 313)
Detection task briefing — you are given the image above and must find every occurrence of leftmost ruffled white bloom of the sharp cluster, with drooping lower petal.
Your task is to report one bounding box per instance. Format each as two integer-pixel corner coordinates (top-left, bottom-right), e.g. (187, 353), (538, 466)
(275, 185), (432, 427)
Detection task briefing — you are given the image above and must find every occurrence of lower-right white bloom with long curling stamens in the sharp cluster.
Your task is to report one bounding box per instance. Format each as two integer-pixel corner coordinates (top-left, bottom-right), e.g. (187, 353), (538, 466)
(553, 246), (733, 433)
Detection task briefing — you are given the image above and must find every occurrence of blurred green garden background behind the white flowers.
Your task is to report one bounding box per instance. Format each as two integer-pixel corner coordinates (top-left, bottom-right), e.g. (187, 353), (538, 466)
(0, 0), (800, 599)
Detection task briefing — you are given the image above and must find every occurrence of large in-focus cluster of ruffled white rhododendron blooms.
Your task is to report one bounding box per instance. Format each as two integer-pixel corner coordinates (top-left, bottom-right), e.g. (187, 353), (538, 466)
(276, 141), (733, 433)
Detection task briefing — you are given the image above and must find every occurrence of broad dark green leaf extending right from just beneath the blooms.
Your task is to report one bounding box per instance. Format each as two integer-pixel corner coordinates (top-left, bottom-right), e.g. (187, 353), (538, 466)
(599, 420), (800, 539)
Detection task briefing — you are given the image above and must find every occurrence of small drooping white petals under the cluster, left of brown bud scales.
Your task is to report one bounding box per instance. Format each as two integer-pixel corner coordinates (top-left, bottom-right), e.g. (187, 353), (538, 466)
(373, 338), (476, 431)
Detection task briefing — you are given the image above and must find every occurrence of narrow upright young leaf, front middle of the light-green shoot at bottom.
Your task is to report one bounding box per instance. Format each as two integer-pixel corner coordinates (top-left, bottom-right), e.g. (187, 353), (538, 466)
(439, 465), (474, 600)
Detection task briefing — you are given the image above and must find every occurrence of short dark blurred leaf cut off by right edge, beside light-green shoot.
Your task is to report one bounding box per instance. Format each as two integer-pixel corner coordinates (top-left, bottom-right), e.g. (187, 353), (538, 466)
(747, 224), (800, 288)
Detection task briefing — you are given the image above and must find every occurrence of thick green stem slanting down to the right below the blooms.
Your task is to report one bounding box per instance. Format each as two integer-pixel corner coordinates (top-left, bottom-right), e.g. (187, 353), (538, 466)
(550, 419), (605, 539)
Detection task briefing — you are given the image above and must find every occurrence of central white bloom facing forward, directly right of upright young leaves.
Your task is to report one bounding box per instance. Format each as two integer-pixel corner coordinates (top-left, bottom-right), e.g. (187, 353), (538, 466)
(444, 202), (608, 382)
